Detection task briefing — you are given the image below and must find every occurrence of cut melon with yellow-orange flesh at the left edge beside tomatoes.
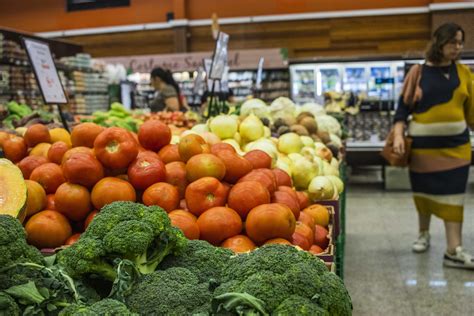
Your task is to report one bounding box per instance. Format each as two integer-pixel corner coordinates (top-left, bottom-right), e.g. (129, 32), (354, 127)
(0, 159), (28, 222)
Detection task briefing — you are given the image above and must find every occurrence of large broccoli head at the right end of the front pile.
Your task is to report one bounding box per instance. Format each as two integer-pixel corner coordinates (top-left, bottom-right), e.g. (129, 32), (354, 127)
(217, 245), (352, 316)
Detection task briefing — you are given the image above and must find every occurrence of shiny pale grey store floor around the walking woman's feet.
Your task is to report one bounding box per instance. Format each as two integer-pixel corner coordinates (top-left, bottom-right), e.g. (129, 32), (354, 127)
(345, 185), (474, 316)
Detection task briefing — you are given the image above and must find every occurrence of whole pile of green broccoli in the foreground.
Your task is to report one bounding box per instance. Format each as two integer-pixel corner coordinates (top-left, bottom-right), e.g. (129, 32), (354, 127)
(0, 202), (352, 316)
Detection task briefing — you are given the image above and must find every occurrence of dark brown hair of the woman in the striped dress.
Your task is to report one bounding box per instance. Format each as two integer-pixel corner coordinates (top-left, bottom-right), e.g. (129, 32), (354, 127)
(426, 23), (465, 64)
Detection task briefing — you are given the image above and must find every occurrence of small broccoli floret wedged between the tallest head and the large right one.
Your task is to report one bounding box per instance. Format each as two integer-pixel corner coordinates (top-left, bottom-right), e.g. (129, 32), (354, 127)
(158, 240), (234, 282)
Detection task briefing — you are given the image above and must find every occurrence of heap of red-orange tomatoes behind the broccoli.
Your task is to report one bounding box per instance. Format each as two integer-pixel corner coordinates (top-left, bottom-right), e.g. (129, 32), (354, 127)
(0, 120), (330, 253)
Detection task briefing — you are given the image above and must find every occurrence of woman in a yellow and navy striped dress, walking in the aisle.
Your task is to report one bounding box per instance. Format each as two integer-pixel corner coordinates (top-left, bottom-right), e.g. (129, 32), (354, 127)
(394, 23), (474, 269)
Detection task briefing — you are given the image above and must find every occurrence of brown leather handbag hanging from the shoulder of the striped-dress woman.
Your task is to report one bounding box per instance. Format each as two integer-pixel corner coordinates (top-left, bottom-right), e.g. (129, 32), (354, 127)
(380, 65), (423, 167)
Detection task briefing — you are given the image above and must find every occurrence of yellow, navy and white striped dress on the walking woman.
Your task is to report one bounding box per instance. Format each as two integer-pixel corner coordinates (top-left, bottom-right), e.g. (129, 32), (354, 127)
(395, 64), (474, 222)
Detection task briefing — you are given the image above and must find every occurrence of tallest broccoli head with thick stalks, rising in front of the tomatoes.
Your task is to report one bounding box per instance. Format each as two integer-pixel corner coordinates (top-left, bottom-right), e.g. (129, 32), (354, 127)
(58, 202), (187, 281)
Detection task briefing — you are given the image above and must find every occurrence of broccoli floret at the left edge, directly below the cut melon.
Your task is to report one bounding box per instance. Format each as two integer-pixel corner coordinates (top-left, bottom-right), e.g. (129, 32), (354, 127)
(0, 215), (44, 269)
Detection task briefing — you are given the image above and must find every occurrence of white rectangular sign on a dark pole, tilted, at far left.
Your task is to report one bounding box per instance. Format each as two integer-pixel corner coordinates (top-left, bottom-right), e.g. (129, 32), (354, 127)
(23, 38), (68, 104)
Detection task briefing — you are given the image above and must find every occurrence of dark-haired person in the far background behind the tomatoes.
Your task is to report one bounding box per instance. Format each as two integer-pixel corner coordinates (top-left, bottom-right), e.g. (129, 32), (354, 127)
(150, 67), (189, 112)
